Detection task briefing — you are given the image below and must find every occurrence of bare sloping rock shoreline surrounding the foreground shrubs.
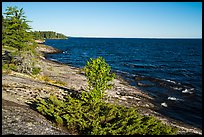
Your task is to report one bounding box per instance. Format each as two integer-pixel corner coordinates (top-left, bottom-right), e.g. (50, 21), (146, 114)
(2, 44), (202, 135)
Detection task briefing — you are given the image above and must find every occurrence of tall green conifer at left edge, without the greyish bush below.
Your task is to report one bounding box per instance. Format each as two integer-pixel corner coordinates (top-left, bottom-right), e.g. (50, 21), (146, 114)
(2, 7), (33, 50)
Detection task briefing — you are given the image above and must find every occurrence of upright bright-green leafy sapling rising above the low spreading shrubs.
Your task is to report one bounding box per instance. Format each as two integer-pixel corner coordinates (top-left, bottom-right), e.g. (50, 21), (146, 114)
(84, 57), (115, 101)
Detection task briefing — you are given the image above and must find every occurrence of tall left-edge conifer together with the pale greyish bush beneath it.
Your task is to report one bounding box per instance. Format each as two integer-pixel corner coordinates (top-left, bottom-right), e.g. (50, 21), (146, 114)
(2, 7), (39, 75)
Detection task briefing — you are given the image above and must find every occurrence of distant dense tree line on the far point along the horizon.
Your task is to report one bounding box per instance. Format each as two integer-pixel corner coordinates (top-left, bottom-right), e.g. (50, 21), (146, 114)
(31, 31), (67, 40)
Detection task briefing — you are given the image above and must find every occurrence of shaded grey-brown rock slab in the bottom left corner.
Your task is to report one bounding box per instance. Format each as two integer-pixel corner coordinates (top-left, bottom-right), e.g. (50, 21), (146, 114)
(2, 99), (69, 135)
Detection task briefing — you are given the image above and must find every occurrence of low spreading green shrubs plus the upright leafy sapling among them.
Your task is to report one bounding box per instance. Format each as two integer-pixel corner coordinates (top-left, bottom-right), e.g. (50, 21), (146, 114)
(35, 57), (177, 135)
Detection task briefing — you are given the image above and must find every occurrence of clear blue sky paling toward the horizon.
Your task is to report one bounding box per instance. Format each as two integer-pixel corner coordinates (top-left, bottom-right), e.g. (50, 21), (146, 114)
(2, 2), (202, 38)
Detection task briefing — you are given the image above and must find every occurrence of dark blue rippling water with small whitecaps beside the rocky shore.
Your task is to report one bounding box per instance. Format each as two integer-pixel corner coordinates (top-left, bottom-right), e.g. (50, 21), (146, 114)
(45, 38), (202, 128)
